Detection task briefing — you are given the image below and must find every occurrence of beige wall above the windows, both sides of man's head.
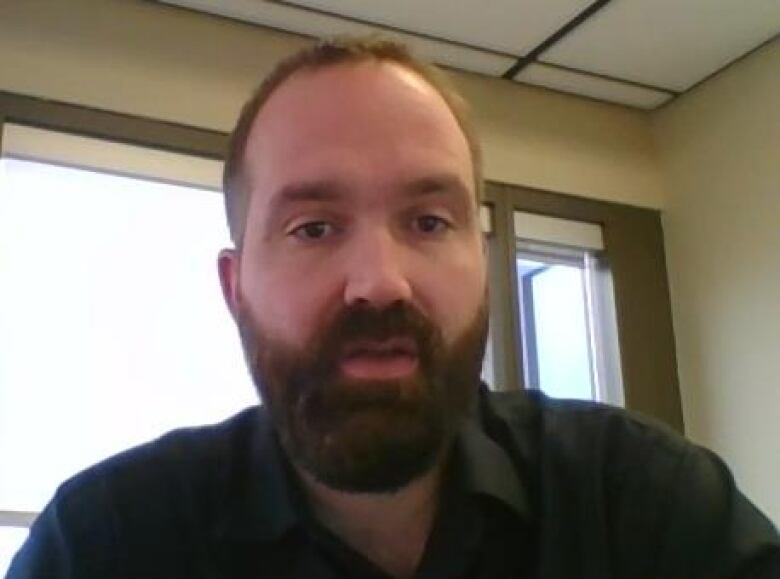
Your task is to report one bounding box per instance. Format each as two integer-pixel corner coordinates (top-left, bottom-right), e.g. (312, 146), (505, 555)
(0, 0), (664, 207)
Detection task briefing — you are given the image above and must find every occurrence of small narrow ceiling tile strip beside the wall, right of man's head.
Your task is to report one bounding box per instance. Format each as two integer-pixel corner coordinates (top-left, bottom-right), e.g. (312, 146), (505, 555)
(515, 64), (672, 109)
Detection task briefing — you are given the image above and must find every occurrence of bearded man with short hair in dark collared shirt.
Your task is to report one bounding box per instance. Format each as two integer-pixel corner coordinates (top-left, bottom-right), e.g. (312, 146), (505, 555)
(10, 40), (780, 579)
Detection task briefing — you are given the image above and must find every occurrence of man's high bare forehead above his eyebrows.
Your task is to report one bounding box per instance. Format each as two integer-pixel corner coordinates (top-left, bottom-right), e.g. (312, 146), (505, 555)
(244, 60), (473, 205)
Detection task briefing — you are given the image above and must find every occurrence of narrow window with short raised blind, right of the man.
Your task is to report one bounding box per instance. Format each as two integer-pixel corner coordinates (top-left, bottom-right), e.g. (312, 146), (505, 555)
(514, 212), (623, 404)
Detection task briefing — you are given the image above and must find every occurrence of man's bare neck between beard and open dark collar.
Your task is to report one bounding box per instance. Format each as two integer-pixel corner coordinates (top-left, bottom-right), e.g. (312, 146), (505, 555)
(296, 460), (444, 578)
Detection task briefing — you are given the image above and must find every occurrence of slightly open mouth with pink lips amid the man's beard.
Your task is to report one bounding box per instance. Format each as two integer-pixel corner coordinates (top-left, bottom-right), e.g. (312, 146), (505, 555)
(340, 337), (419, 380)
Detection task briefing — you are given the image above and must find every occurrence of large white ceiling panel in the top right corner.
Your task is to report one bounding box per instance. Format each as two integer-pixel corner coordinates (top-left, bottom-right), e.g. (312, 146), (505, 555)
(541, 0), (780, 91)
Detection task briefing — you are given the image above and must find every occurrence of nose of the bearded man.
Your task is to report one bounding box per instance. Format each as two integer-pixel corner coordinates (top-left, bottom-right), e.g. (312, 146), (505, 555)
(344, 228), (412, 309)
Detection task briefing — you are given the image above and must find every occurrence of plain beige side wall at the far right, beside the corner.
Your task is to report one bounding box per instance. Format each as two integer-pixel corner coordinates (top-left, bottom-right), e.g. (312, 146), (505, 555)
(654, 40), (780, 523)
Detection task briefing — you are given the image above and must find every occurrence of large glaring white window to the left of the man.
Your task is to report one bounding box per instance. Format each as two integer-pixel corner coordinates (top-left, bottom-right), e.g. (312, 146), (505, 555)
(0, 128), (257, 575)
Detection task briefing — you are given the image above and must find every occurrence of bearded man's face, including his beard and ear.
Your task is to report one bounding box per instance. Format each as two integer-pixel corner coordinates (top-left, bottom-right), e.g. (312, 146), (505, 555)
(220, 62), (487, 492)
